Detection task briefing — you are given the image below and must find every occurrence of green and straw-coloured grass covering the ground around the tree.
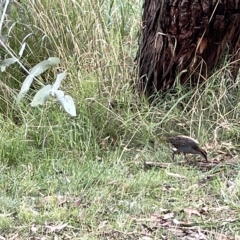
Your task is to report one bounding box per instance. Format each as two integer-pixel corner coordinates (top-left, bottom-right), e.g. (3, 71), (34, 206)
(0, 0), (240, 239)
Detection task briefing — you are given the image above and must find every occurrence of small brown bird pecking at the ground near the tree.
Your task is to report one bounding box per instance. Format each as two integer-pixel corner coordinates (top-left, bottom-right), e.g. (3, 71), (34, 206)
(166, 135), (208, 161)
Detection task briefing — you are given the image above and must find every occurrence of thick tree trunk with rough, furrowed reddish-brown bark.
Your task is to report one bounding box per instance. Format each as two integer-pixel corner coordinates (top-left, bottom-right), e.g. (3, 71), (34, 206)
(137, 0), (240, 96)
